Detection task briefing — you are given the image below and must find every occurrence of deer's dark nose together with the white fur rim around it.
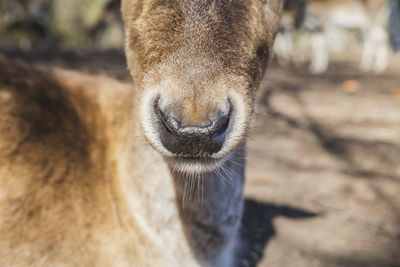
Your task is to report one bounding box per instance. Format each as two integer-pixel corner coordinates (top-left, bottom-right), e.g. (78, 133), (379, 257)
(142, 89), (247, 173)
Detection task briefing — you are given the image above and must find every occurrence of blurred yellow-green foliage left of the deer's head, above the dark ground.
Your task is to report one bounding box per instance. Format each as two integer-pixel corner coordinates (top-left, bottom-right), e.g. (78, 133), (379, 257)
(0, 0), (123, 50)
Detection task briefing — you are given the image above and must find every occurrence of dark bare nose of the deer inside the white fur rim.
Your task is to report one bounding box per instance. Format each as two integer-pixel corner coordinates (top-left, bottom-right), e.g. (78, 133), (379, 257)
(156, 103), (230, 157)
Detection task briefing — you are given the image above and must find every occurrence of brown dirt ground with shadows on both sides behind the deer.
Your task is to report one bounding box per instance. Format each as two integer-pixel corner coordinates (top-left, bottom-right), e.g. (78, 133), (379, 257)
(0, 51), (400, 267)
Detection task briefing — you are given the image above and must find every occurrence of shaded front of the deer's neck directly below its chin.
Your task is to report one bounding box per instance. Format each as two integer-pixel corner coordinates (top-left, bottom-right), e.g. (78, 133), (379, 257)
(171, 144), (245, 266)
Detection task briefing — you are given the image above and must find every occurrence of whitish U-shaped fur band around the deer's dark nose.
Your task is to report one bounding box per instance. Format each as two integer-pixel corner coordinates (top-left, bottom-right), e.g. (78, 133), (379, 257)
(140, 87), (250, 174)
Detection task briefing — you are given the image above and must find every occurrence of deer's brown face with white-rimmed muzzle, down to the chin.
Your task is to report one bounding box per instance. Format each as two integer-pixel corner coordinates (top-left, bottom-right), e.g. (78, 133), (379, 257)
(122, 0), (283, 172)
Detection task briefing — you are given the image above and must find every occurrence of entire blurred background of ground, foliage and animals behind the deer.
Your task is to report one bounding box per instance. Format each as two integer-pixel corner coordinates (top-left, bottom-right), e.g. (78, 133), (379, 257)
(0, 0), (400, 267)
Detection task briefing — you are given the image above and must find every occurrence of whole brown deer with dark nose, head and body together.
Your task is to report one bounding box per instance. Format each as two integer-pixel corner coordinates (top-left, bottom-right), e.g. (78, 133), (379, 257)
(0, 0), (283, 266)
